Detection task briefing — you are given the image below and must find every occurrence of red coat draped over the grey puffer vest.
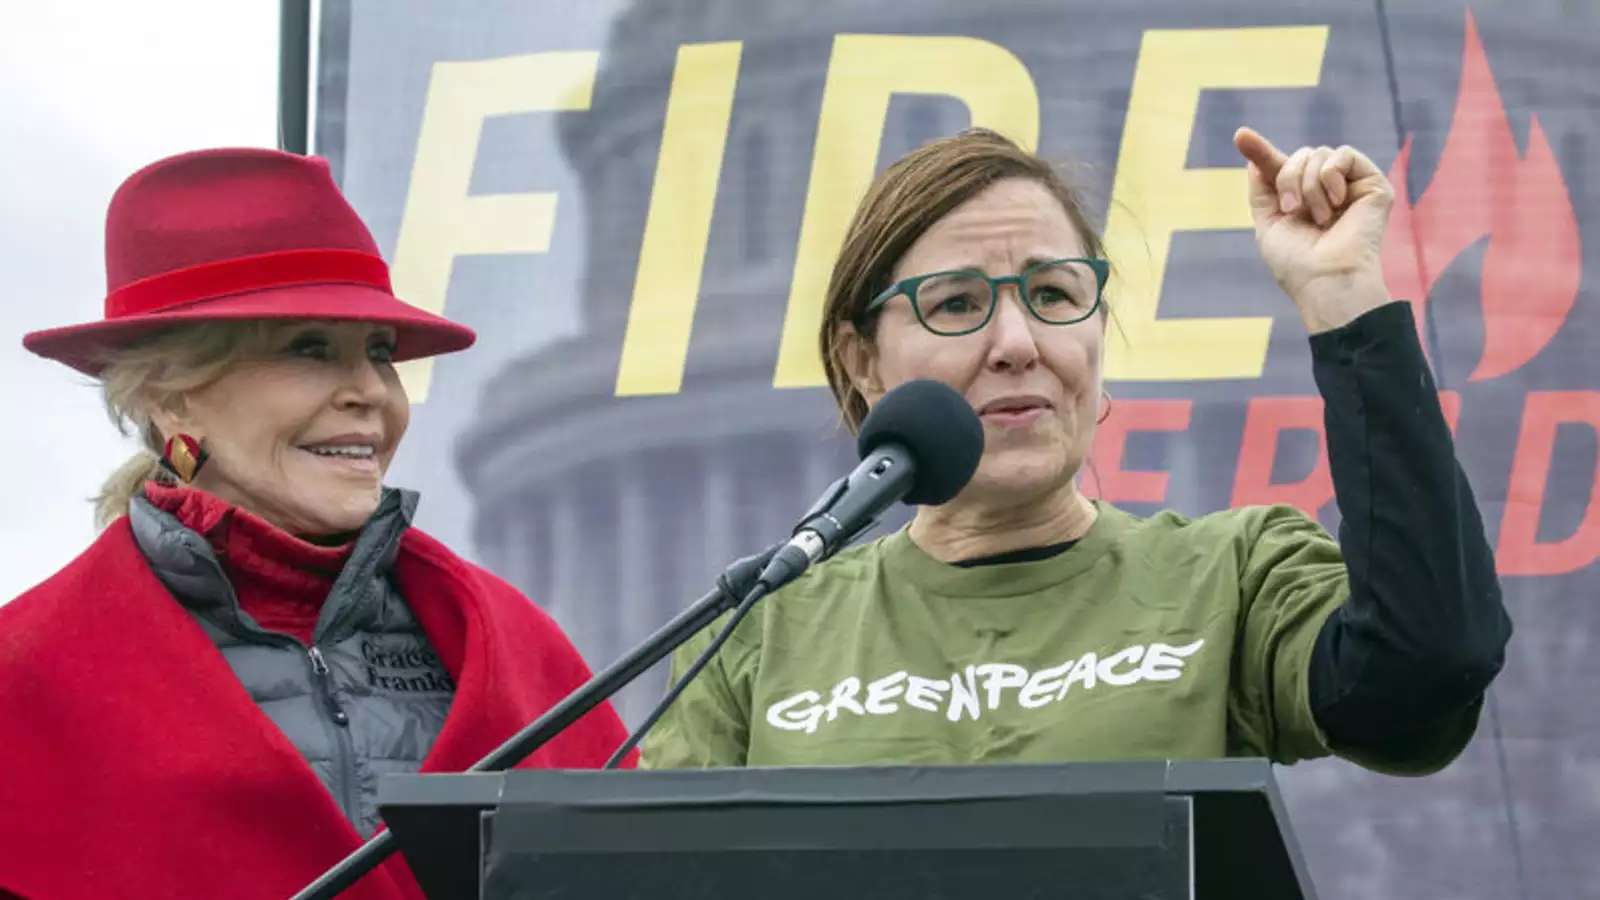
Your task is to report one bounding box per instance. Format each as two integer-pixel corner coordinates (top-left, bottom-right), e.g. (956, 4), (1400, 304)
(0, 517), (626, 900)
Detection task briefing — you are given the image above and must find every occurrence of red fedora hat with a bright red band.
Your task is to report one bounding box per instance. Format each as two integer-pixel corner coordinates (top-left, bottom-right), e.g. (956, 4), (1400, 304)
(22, 149), (475, 375)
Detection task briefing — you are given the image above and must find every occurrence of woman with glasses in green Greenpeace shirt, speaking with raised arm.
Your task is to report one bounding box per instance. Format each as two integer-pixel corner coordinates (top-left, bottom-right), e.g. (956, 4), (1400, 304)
(645, 128), (1510, 773)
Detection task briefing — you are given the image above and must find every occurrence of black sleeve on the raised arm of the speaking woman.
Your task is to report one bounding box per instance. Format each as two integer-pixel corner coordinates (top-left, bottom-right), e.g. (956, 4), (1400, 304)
(1309, 303), (1510, 746)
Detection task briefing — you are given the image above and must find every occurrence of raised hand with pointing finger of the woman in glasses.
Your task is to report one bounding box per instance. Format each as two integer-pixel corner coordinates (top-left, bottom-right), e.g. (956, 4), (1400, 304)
(1234, 128), (1394, 335)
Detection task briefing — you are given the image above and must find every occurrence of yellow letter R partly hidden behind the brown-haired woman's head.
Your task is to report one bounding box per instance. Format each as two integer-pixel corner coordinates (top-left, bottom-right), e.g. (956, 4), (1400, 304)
(773, 34), (1038, 388)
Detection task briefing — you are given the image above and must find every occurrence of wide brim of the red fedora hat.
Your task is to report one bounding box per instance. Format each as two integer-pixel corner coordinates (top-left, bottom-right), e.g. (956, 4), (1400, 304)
(22, 283), (477, 375)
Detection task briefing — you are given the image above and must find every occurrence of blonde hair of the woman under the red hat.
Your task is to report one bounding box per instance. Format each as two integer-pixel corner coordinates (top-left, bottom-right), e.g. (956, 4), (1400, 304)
(94, 319), (275, 528)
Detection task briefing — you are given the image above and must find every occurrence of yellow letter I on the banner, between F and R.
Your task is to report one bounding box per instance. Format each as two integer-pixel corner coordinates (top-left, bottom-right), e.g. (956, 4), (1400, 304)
(616, 42), (739, 396)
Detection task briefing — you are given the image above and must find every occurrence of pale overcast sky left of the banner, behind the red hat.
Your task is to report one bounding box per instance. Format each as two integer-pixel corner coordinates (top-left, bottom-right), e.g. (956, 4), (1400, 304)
(0, 0), (278, 604)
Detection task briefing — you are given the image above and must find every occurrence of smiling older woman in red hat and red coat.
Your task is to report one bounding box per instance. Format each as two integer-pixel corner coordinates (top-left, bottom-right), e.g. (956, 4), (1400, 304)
(0, 149), (626, 898)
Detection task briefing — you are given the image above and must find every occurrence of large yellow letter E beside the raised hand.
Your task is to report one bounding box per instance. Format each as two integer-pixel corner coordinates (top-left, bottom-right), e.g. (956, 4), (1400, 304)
(1106, 26), (1328, 381)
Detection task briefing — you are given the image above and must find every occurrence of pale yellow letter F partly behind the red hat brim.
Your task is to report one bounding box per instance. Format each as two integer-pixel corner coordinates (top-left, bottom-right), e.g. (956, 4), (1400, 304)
(392, 51), (600, 404)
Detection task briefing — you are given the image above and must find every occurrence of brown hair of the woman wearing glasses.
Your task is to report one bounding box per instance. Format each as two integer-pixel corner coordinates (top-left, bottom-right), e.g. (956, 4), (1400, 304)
(818, 128), (1106, 431)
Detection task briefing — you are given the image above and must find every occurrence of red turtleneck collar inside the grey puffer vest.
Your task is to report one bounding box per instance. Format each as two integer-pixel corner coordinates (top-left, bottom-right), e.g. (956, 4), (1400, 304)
(144, 482), (355, 645)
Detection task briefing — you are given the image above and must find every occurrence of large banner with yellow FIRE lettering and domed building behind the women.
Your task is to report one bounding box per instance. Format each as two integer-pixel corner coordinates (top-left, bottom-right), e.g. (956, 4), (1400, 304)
(315, 0), (1600, 900)
